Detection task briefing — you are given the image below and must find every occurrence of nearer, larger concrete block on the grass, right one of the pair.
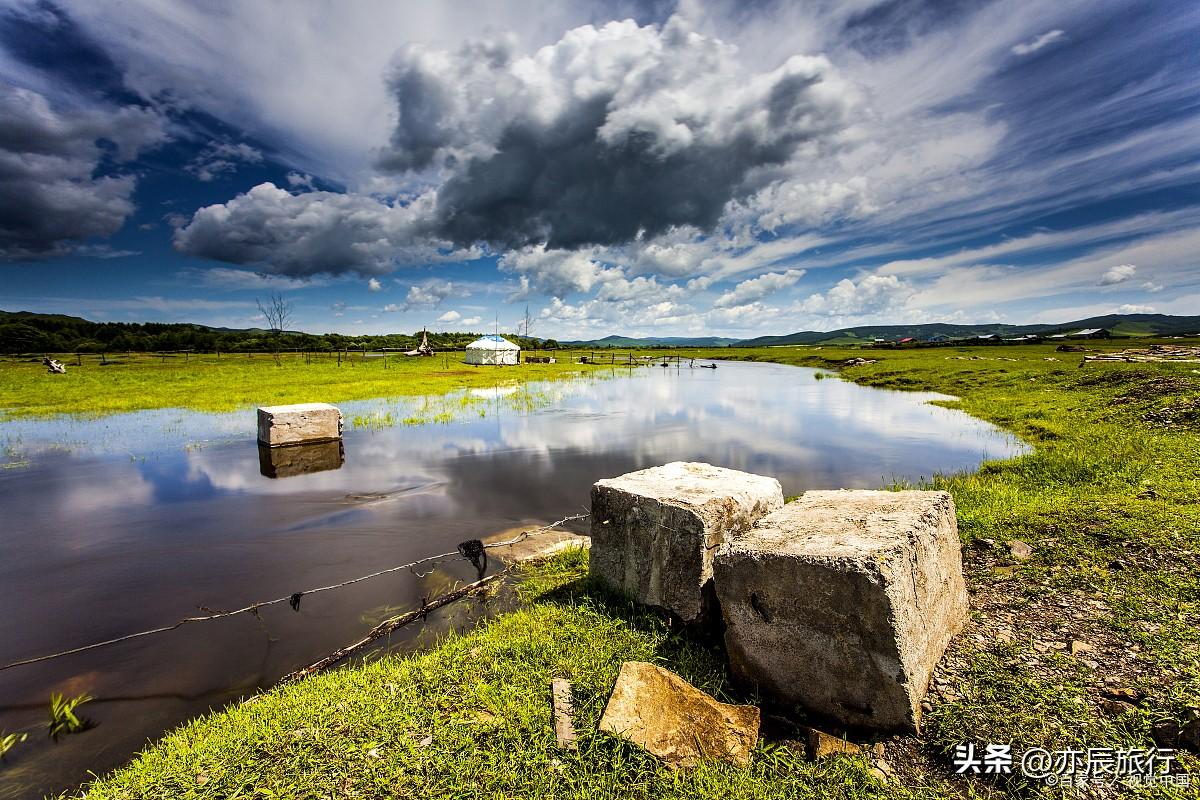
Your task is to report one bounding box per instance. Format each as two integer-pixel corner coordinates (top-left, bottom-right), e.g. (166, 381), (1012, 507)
(714, 491), (967, 729)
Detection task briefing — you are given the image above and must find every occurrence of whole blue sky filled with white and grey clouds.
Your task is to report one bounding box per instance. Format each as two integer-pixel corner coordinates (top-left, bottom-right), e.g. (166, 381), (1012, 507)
(0, 0), (1200, 339)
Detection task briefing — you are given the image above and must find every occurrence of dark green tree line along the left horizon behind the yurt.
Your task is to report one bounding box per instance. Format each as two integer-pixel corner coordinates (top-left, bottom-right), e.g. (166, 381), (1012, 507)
(0, 312), (558, 354)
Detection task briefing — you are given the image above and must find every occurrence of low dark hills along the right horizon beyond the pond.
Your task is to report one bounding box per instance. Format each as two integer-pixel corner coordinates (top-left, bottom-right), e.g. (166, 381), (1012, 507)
(734, 314), (1200, 347)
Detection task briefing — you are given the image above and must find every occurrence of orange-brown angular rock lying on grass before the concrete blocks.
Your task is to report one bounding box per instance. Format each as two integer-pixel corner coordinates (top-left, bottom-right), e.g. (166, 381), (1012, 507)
(600, 661), (761, 769)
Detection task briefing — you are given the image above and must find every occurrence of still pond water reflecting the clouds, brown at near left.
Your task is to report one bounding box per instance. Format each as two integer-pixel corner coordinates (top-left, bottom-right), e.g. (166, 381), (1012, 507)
(0, 363), (1021, 799)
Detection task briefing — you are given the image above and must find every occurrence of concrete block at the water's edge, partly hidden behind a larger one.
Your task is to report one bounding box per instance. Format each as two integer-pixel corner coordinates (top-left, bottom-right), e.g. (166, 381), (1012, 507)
(589, 462), (784, 622)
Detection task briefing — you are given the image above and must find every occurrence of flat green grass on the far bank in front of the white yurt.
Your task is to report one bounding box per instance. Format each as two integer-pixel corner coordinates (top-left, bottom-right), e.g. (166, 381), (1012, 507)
(0, 353), (609, 419)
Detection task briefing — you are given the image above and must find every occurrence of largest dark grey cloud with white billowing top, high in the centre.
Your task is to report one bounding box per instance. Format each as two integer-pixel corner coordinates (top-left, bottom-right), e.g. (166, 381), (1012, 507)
(379, 19), (853, 248)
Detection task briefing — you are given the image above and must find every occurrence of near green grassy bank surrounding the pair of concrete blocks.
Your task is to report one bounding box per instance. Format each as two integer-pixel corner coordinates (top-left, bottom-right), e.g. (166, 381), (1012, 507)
(63, 347), (1200, 799)
